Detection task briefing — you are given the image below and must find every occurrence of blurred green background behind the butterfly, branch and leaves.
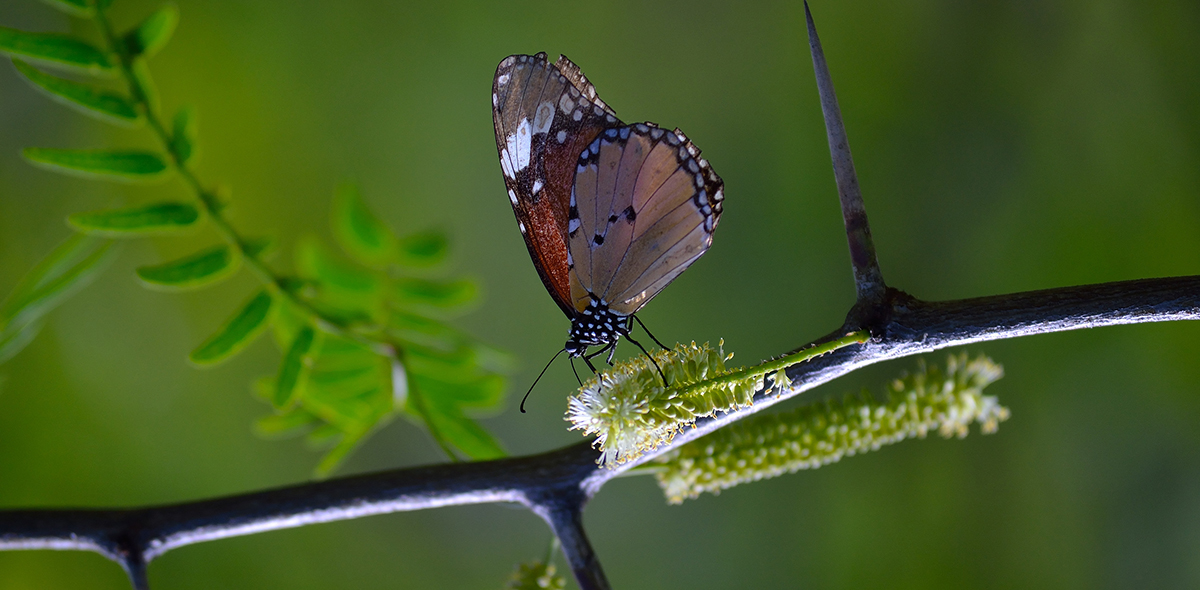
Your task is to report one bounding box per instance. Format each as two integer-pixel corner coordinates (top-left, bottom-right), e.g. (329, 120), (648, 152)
(0, 0), (1200, 590)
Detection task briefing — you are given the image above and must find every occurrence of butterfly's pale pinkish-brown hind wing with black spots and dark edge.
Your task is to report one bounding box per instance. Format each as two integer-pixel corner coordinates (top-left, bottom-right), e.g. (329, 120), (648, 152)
(568, 124), (724, 315)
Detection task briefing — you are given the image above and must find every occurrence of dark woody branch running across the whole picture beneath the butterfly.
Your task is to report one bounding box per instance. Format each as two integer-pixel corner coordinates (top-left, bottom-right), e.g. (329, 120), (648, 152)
(0, 276), (1200, 589)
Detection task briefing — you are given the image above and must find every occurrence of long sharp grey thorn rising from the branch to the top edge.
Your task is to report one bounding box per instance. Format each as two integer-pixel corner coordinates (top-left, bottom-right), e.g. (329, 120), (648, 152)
(804, 2), (887, 306)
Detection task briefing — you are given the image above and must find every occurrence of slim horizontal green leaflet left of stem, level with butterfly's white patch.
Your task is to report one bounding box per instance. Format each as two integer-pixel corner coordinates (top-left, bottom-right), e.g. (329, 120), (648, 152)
(20, 148), (168, 182)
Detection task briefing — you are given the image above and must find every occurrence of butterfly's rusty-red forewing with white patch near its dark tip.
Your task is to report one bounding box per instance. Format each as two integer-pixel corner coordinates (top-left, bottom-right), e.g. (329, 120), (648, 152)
(492, 53), (622, 318)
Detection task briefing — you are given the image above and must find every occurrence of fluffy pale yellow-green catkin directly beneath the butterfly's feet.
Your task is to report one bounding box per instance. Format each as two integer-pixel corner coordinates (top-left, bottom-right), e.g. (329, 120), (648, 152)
(566, 342), (764, 468)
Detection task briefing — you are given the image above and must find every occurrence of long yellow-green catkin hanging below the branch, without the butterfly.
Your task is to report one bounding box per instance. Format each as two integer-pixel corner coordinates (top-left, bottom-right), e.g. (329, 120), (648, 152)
(654, 354), (1009, 504)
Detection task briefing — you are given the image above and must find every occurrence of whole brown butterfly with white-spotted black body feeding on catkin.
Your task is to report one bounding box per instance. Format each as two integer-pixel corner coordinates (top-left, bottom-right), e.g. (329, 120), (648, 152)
(492, 53), (724, 386)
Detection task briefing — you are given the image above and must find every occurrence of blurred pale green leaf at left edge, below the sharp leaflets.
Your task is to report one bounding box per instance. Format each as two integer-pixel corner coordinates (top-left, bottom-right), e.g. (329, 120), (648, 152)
(0, 235), (112, 333)
